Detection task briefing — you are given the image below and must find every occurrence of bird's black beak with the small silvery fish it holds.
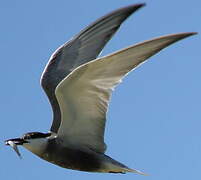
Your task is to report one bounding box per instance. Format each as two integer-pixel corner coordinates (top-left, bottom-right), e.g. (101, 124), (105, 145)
(5, 138), (28, 159)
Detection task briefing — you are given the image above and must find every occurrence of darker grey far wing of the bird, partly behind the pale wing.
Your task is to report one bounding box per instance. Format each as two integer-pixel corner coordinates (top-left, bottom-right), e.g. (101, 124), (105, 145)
(41, 4), (144, 133)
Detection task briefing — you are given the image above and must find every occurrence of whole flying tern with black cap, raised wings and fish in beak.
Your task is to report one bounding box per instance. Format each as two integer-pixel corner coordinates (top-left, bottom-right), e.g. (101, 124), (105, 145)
(5, 3), (196, 175)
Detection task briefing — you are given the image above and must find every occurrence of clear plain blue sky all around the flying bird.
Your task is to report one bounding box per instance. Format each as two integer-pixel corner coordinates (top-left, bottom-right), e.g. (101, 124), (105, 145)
(0, 0), (201, 180)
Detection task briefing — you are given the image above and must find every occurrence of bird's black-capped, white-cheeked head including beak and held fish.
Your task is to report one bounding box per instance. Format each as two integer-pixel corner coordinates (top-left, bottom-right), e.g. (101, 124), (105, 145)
(5, 132), (56, 157)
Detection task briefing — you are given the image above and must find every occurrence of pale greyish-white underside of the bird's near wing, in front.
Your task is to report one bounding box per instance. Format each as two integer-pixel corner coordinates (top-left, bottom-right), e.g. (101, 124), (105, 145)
(56, 33), (195, 152)
